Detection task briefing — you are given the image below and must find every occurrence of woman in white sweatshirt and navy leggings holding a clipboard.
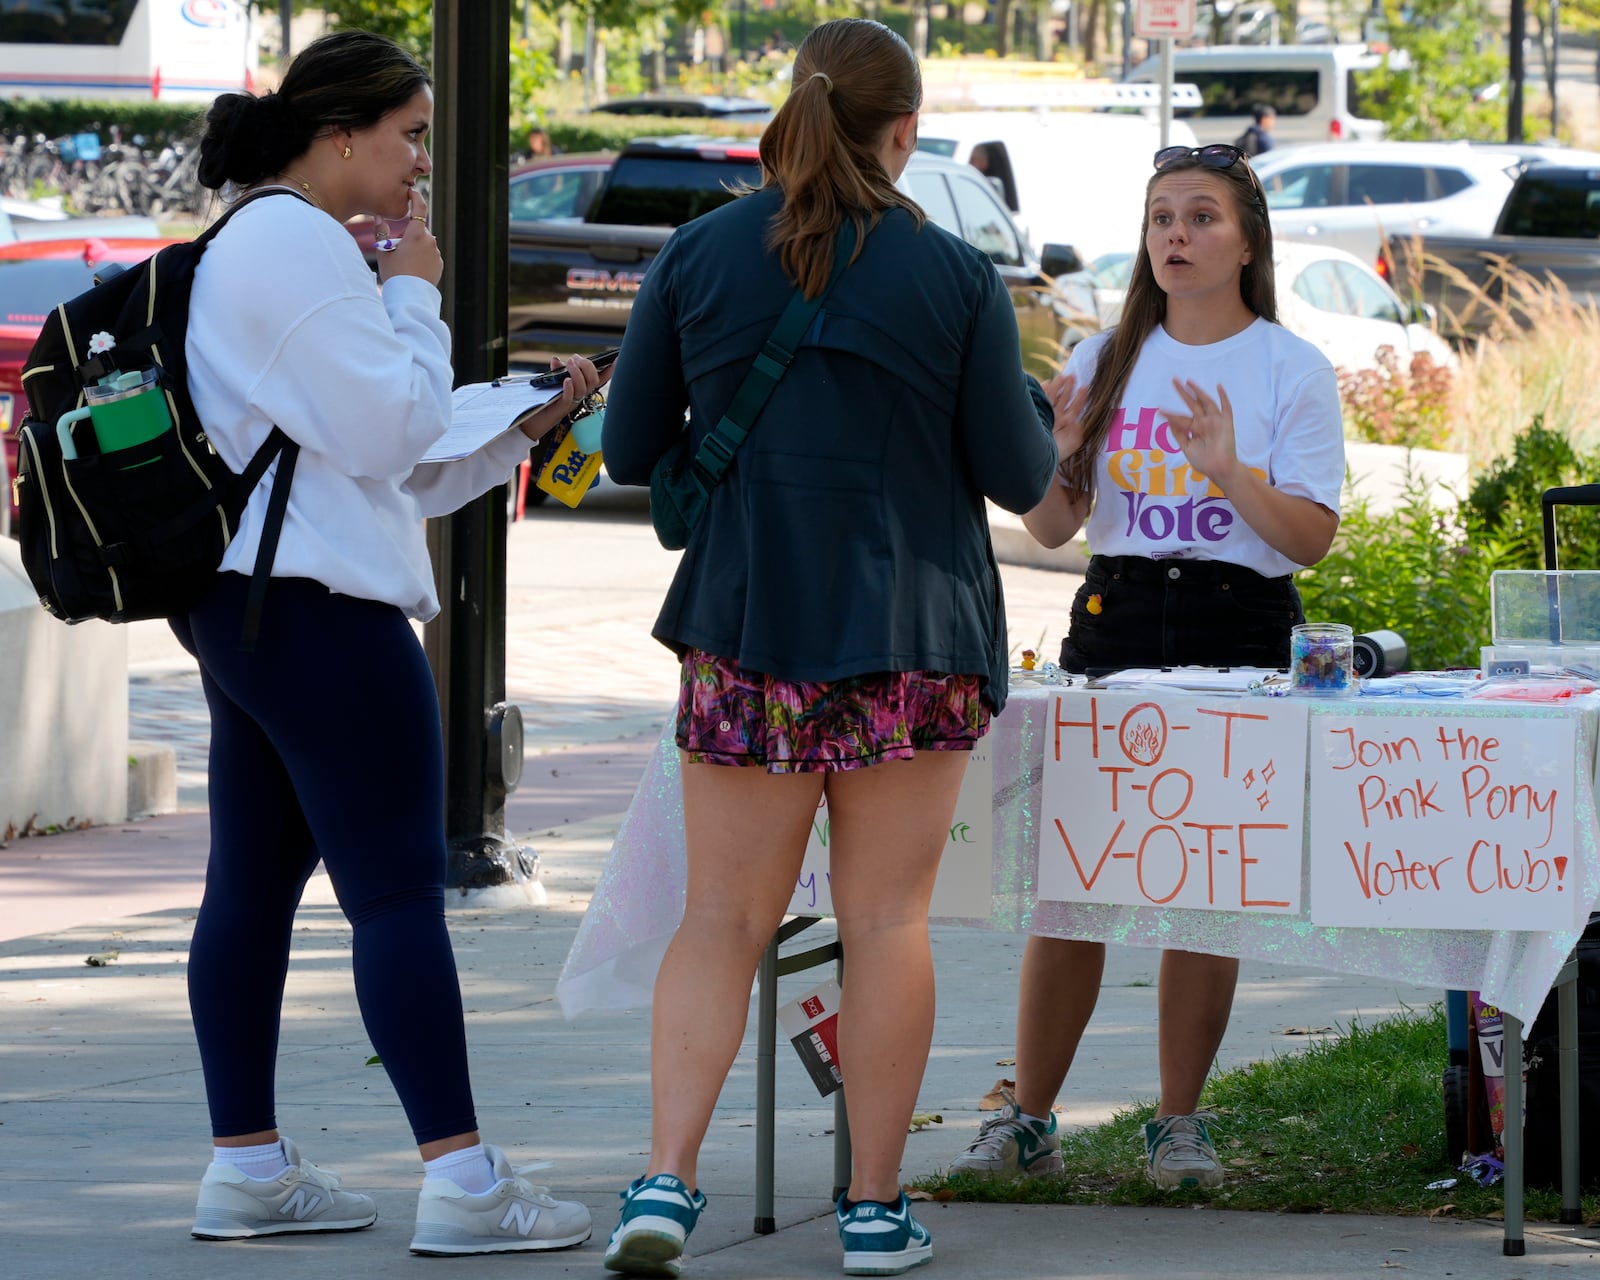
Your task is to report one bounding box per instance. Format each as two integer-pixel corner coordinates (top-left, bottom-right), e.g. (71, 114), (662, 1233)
(173, 30), (605, 1256)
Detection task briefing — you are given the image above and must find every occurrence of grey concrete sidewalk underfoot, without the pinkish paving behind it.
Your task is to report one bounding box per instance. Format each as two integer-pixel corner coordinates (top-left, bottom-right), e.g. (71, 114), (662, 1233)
(0, 806), (1600, 1280)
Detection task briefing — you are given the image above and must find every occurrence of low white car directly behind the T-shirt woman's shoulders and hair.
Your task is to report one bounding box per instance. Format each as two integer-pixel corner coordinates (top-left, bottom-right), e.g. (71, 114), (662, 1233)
(1090, 240), (1456, 370)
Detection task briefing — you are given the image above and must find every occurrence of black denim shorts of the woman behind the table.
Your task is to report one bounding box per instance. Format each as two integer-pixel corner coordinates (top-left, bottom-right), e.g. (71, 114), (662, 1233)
(1061, 555), (1306, 674)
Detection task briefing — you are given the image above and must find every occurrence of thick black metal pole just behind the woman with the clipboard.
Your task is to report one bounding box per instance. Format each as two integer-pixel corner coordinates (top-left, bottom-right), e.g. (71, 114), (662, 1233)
(426, 0), (538, 890)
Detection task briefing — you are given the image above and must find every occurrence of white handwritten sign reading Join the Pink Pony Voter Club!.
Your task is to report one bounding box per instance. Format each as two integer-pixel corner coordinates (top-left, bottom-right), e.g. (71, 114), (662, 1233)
(1309, 714), (1584, 931)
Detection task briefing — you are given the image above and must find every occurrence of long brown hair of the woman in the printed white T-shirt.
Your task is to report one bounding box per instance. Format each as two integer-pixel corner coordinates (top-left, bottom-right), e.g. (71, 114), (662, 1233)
(1062, 155), (1278, 490)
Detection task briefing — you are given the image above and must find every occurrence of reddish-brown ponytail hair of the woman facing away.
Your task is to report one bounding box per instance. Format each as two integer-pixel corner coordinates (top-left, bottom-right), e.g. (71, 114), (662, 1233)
(762, 18), (923, 298)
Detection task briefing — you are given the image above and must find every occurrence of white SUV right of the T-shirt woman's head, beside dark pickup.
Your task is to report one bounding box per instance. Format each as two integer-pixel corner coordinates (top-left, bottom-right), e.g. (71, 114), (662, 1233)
(1251, 142), (1542, 262)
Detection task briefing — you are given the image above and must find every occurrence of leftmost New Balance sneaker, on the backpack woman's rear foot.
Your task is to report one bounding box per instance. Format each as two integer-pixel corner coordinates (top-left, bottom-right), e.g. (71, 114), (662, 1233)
(189, 1138), (378, 1240)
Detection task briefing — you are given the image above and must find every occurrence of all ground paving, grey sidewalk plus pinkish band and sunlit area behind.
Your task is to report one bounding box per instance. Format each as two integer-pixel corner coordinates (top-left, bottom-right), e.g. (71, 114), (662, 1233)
(0, 512), (1600, 1280)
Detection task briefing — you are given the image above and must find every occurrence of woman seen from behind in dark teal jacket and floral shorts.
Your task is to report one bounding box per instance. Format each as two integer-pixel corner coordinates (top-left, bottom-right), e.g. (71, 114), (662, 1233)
(603, 19), (1056, 1275)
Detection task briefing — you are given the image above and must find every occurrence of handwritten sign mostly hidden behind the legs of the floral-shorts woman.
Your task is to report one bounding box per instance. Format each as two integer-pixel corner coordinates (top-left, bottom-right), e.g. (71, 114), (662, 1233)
(789, 741), (994, 920)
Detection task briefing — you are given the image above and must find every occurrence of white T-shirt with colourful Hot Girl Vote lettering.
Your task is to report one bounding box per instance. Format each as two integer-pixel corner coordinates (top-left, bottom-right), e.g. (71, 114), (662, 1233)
(1066, 318), (1344, 578)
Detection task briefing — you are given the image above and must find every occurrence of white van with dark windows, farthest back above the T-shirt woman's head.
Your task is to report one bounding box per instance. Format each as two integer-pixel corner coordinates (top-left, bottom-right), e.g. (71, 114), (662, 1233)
(1128, 45), (1400, 146)
